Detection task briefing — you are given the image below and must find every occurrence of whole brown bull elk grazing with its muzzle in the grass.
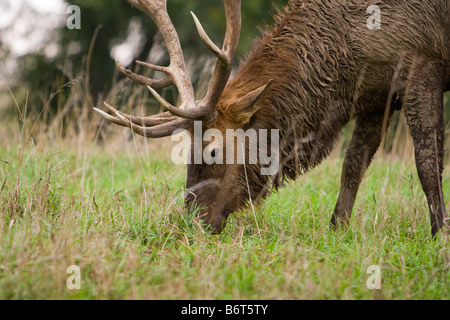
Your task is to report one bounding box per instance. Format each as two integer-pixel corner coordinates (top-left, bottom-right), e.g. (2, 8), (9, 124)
(97, 0), (450, 235)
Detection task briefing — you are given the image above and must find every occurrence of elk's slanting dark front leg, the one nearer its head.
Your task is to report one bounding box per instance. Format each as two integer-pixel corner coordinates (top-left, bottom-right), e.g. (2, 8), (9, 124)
(331, 112), (392, 229)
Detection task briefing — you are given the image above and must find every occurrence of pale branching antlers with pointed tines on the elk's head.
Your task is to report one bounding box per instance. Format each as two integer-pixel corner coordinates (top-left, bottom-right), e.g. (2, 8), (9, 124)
(94, 0), (241, 138)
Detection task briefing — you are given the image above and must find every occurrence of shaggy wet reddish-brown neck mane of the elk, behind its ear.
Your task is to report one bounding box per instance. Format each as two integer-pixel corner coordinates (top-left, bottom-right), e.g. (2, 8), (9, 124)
(219, 1), (357, 201)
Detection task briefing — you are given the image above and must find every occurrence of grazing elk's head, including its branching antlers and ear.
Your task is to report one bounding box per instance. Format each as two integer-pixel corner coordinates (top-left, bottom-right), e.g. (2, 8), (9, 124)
(95, 0), (269, 233)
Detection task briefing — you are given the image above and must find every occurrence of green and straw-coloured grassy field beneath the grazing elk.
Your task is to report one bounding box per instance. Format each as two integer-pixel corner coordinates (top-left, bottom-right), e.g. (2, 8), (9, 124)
(0, 110), (450, 299)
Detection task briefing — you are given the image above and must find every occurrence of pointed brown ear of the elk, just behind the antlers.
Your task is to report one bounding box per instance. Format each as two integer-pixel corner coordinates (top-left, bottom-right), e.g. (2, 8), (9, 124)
(231, 80), (272, 124)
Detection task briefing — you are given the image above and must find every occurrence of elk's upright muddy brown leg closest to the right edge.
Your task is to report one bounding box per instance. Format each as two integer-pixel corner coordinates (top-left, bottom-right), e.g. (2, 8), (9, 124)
(404, 64), (446, 237)
